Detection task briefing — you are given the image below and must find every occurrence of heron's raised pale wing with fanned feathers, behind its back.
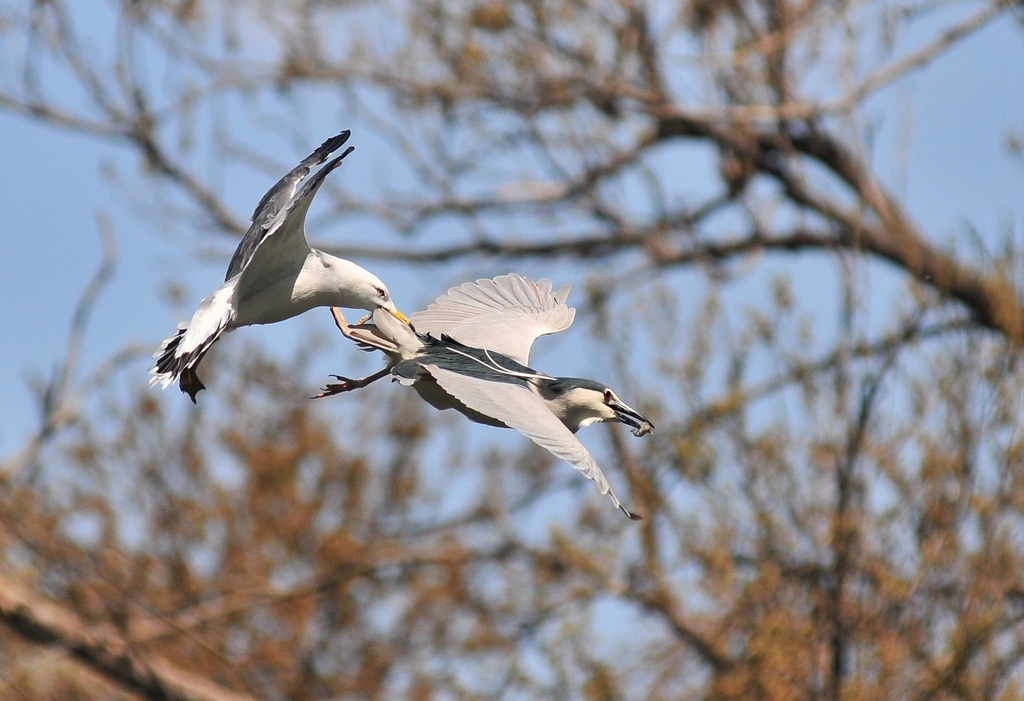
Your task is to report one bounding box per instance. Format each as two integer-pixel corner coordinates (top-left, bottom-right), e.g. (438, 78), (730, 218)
(412, 273), (575, 365)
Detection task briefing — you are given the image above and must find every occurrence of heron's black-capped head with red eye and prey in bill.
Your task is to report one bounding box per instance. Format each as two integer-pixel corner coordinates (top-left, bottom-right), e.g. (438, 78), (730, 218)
(541, 378), (654, 436)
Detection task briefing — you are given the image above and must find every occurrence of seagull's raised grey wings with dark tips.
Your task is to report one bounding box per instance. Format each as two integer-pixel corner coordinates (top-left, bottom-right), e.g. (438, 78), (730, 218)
(224, 131), (351, 281)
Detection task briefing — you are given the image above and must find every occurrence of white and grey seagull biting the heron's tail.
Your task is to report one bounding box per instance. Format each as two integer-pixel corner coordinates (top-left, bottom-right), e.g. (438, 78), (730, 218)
(150, 130), (409, 403)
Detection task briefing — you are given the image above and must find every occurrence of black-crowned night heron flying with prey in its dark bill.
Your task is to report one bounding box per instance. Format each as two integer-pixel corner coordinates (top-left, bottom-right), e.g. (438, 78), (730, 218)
(316, 273), (654, 521)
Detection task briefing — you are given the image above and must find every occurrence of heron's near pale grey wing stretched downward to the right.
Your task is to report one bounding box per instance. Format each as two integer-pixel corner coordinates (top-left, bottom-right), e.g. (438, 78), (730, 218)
(423, 364), (640, 520)
